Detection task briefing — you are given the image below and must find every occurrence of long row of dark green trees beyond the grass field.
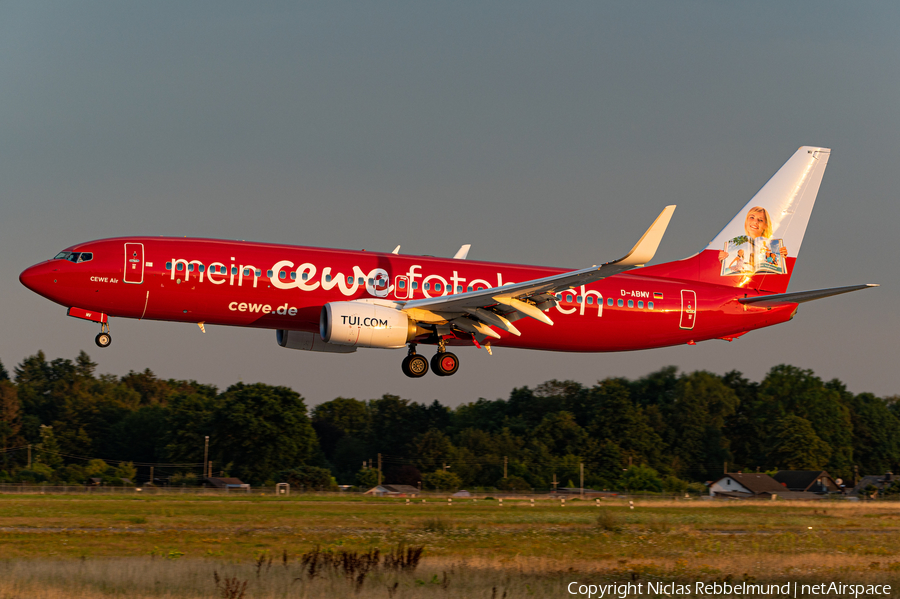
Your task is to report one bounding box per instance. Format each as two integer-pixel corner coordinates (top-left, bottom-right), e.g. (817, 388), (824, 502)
(0, 352), (900, 492)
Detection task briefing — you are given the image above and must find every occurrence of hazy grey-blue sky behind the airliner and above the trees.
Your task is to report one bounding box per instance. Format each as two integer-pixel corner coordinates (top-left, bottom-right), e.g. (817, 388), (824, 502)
(0, 2), (900, 405)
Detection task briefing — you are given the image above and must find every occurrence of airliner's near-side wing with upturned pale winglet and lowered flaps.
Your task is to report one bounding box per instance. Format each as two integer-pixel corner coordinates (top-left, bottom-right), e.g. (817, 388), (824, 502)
(401, 206), (675, 338)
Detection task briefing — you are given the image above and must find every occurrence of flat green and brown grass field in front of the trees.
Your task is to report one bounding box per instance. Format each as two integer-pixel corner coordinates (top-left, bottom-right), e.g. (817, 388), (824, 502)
(0, 495), (900, 599)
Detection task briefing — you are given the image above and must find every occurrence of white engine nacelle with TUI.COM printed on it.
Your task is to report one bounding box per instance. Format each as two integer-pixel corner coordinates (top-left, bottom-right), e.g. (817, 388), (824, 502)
(319, 302), (420, 349)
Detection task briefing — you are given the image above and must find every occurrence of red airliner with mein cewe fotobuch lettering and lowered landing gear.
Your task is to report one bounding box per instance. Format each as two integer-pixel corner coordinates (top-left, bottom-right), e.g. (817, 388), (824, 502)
(19, 147), (875, 377)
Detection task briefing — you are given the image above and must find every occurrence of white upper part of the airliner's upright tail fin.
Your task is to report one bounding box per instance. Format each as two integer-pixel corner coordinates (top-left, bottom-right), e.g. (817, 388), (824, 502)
(706, 146), (831, 257)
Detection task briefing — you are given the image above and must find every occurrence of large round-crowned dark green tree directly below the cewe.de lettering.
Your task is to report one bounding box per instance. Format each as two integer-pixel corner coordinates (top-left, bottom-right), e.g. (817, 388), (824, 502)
(210, 383), (316, 484)
